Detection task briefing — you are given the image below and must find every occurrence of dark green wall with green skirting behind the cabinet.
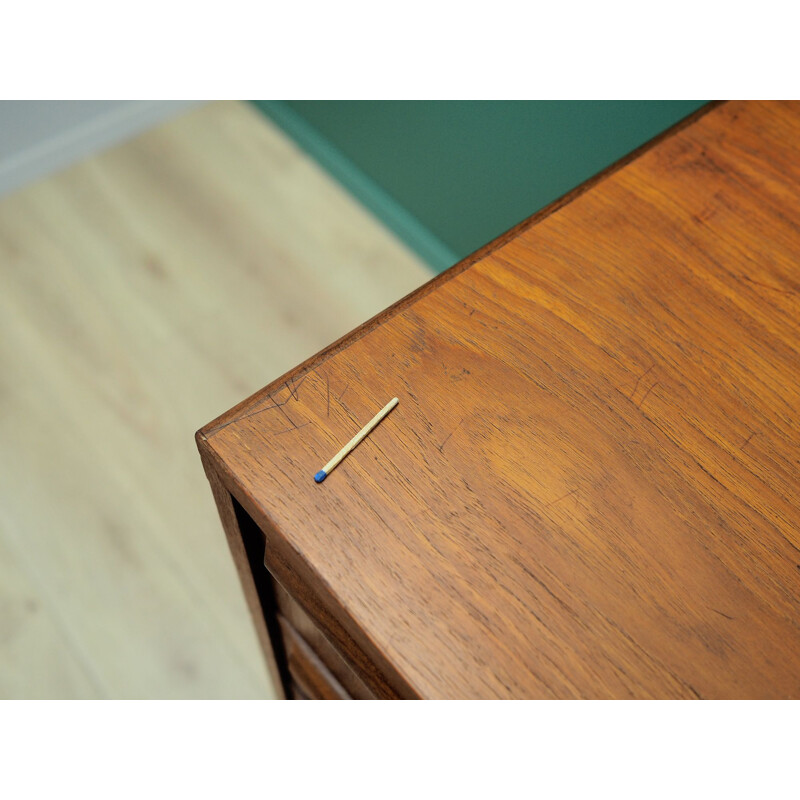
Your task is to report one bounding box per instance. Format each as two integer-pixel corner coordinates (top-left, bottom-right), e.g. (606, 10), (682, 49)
(256, 100), (703, 271)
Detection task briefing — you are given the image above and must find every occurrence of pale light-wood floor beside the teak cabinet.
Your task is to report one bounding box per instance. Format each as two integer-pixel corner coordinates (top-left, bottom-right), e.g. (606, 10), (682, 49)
(0, 103), (430, 698)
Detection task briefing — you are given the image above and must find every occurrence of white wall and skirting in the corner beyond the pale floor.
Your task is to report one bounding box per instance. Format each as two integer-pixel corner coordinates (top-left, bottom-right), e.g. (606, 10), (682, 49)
(0, 100), (196, 195)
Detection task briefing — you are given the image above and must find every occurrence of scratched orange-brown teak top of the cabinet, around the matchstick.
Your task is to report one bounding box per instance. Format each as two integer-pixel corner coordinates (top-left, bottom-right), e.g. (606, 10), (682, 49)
(200, 103), (800, 697)
